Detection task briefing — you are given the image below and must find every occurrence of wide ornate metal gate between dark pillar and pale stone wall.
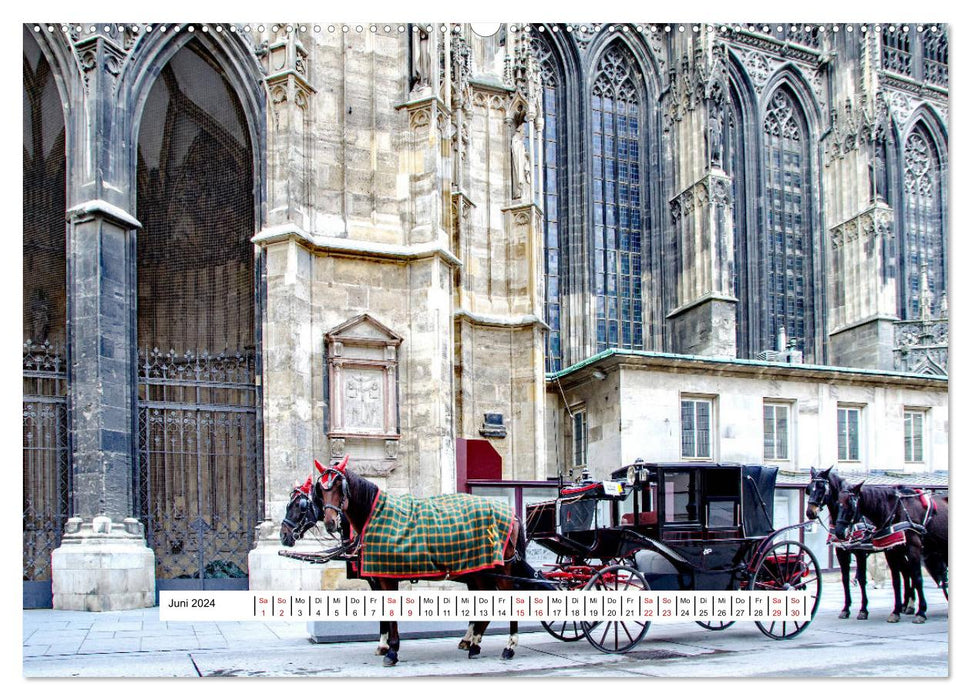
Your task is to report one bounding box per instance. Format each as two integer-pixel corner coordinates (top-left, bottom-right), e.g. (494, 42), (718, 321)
(135, 348), (263, 589)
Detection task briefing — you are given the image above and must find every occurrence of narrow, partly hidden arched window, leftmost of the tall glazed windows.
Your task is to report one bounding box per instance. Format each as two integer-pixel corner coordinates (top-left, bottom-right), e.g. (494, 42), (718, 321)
(533, 41), (568, 372)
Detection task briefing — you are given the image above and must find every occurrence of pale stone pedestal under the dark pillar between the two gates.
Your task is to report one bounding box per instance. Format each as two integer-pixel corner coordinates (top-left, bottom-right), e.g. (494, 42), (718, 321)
(51, 516), (155, 612)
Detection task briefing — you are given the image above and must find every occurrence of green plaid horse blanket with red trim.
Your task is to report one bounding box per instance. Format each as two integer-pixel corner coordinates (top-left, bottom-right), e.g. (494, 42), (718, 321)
(361, 491), (513, 578)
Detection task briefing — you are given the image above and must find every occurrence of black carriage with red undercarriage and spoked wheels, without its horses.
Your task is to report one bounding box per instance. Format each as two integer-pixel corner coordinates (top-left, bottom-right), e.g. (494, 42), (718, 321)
(526, 462), (822, 653)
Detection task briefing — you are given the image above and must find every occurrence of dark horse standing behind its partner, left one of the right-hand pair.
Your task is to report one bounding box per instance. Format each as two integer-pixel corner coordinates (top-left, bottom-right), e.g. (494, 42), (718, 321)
(806, 467), (914, 620)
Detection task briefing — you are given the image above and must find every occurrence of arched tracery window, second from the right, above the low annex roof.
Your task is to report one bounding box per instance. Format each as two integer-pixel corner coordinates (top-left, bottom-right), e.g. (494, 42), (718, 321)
(762, 89), (813, 350)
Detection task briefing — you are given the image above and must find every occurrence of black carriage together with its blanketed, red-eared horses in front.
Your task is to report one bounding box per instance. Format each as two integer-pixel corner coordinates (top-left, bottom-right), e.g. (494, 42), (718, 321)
(280, 459), (821, 665)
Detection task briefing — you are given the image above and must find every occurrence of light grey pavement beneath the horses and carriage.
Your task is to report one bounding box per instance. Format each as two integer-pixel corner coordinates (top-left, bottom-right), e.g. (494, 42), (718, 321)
(23, 574), (949, 678)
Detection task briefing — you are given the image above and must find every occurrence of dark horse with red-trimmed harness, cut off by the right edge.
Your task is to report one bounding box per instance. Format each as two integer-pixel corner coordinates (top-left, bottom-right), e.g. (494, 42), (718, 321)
(836, 482), (948, 624)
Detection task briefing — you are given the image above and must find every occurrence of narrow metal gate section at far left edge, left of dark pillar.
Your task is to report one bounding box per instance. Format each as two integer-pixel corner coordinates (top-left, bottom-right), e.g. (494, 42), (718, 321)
(23, 340), (71, 607)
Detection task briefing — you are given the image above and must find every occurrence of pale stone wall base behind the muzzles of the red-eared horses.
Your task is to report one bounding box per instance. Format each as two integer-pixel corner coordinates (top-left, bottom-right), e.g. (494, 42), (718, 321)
(248, 520), (345, 591)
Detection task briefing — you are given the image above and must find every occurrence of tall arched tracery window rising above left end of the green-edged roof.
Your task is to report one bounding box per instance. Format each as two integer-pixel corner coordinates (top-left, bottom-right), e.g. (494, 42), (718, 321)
(591, 46), (644, 352)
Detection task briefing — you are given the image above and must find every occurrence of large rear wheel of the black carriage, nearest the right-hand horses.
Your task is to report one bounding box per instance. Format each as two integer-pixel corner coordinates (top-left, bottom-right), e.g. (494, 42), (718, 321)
(748, 540), (823, 639)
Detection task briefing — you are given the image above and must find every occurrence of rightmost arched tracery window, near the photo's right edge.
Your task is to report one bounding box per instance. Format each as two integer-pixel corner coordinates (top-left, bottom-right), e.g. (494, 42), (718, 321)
(901, 127), (947, 318)
